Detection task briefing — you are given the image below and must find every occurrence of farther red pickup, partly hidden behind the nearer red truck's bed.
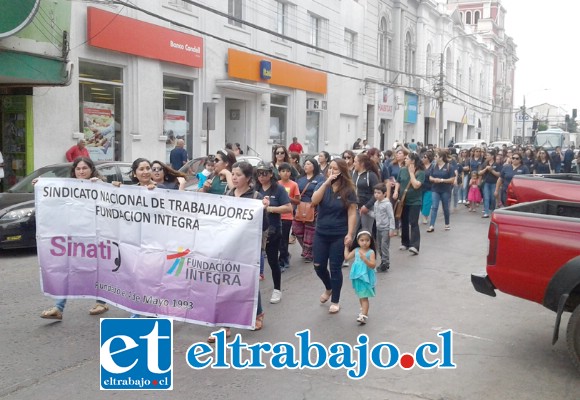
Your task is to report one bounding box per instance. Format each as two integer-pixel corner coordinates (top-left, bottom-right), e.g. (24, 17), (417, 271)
(507, 174), (580, 206)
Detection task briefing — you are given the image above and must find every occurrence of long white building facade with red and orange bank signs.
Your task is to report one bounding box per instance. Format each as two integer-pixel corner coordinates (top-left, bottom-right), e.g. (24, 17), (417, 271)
(0, 0), (516, 179)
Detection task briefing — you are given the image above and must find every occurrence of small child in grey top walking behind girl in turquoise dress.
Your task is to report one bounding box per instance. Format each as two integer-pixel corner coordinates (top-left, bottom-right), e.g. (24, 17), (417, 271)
(373, 183), (397, 272)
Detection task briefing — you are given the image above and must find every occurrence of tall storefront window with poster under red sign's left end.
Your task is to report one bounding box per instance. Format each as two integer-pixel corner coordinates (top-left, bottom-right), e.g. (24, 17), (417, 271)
(79, 61), (123, 161)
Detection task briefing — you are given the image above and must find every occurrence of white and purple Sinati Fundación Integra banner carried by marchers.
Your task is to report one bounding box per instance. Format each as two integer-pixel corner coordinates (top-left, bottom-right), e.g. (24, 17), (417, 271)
(35, 178), (263, 328)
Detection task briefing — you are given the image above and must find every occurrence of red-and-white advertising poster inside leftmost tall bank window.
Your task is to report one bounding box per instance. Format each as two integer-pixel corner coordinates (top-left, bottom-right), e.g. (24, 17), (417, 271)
(83, 101), (115, 161)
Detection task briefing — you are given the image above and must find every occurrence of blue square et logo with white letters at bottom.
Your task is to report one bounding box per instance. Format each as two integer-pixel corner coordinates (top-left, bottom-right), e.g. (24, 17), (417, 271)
(100, 318), (173, 390)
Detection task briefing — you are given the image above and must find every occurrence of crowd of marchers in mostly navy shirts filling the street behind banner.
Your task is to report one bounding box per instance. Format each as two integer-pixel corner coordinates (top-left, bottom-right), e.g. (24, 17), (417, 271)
(41, 139), (574, 336)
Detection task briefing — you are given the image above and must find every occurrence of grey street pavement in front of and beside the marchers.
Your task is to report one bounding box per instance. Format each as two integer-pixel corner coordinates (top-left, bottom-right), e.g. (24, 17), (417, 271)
(0, 205), (580, 400)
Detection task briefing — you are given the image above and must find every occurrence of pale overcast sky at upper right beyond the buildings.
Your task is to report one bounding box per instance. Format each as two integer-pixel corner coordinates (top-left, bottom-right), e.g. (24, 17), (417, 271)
(501, 0), (580, 113)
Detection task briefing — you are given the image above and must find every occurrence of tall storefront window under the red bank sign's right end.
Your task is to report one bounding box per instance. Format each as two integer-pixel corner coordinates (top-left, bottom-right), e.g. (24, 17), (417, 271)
(163, 76), (193, 162)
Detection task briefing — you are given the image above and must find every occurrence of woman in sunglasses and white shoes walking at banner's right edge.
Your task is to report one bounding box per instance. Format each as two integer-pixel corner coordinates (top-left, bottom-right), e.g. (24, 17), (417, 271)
(256, 163), (292, 304)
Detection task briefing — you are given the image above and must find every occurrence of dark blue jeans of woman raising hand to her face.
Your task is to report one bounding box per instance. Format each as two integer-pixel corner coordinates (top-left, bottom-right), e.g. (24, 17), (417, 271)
(312, 231), (344, 304)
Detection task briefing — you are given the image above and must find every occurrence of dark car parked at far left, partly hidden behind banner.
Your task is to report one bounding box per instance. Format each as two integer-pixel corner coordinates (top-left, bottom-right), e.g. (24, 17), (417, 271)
(0, 161), (132, 250)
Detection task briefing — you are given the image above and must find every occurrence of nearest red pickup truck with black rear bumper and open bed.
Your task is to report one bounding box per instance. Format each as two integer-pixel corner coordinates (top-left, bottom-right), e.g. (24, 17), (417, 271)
(471, 200), (580, 371)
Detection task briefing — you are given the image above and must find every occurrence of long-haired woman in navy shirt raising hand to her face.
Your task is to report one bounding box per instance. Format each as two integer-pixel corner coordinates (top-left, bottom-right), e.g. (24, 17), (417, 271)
(312, 159), (357, 314)
